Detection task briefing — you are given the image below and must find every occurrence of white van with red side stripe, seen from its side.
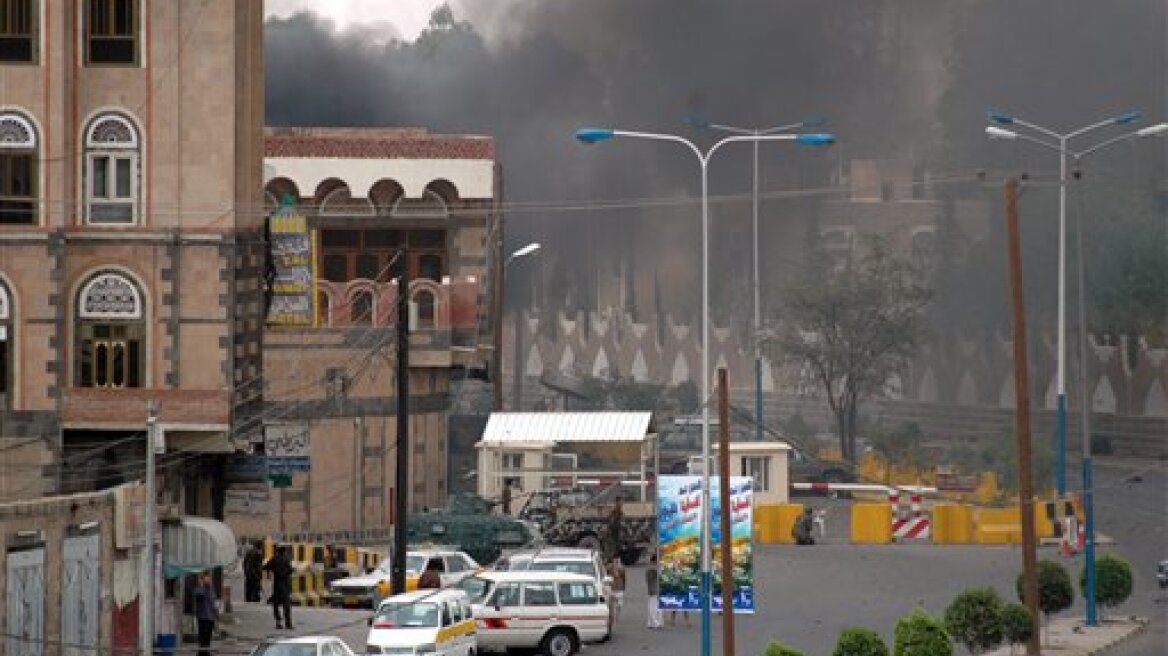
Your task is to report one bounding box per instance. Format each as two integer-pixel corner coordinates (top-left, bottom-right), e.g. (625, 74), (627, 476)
(459, 571), (609, 656)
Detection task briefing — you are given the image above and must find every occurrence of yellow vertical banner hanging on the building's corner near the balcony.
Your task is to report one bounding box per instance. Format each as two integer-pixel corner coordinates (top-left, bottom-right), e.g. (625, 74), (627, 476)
(267, 205), (317, 326)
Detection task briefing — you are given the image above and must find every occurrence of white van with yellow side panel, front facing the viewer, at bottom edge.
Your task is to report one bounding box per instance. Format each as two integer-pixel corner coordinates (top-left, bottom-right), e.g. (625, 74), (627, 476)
(366, 588), (478, 656)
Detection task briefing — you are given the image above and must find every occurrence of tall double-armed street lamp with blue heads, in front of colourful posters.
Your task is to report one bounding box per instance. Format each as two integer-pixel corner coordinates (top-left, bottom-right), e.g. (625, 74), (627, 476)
(576, 127), (835, 656)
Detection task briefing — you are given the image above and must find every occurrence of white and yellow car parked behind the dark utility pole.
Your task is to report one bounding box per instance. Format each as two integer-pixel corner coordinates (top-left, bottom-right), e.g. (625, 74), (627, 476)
(326, 549), (480, 608)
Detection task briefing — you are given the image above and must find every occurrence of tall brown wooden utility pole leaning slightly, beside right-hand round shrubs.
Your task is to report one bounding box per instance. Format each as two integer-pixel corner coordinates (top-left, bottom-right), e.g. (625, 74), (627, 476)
(1006, 179), (1042, 656)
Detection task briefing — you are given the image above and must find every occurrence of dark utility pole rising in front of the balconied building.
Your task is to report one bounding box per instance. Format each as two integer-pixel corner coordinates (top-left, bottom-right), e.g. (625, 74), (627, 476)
(390, 247), (410, 594)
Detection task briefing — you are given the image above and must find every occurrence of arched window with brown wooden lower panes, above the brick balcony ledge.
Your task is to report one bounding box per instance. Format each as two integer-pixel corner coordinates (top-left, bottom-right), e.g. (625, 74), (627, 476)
(75, 272), (146, 389)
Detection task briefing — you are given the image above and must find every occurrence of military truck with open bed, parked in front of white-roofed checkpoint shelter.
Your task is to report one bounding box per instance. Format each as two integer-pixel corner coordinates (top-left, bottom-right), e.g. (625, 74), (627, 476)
(519, 484), (656, 566)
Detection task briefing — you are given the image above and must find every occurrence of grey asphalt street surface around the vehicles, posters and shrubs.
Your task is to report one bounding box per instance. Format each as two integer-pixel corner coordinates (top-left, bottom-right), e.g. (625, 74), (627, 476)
(223, 461), (1168, 656)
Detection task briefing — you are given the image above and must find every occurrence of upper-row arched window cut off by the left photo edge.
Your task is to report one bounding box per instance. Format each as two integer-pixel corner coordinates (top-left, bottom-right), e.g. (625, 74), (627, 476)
(0, 112), (40, 224)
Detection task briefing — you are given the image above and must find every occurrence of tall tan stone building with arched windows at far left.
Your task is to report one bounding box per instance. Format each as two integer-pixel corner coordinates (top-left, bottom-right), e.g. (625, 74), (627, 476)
(0, 0), (264, 516)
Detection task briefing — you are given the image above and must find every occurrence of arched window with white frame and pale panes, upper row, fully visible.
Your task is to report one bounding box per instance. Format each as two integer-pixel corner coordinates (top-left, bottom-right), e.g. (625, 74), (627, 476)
(85, 113), (139, 225)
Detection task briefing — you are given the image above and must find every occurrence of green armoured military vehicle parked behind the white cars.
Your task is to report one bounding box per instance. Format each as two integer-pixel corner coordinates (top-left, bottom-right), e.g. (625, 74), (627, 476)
(405, 494), (540, 565)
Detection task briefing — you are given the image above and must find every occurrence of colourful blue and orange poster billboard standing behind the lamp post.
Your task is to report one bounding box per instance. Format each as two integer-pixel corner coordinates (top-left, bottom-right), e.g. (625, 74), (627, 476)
(658, 476), (755, 613)
